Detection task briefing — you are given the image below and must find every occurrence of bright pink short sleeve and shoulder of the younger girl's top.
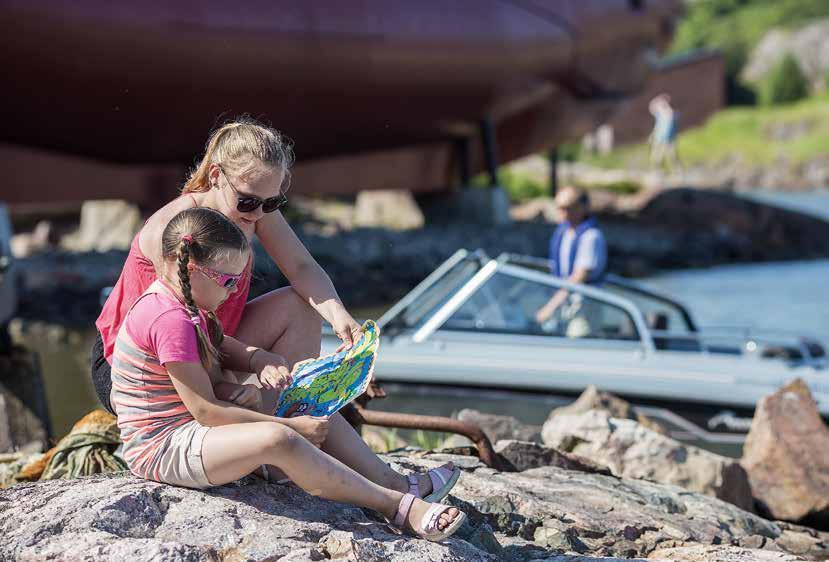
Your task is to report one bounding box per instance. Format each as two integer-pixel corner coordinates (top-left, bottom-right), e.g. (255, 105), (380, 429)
(126, 295), (206, 365)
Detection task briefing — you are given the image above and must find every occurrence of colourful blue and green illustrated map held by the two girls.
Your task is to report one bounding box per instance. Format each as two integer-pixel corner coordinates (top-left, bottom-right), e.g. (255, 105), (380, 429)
(276, 320), (380, 418)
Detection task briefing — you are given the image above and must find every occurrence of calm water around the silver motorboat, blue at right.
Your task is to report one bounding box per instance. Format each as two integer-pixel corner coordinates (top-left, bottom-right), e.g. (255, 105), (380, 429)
(16, 190), (829, 437)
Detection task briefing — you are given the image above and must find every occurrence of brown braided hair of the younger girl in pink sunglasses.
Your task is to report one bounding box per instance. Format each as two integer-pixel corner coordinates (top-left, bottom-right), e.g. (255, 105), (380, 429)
(161, 207), (250, 370)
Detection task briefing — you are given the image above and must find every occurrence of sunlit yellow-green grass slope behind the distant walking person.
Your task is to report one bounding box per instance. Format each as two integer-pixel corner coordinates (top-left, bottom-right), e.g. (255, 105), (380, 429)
(583, 95), (829, 169)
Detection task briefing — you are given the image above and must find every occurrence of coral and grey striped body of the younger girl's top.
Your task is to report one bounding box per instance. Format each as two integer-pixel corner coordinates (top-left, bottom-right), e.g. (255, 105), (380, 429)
(110, 281), (204, 481)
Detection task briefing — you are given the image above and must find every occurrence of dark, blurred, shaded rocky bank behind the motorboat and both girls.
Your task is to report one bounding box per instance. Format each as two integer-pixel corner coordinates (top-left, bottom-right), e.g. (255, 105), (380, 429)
(11, 189), (829, 325)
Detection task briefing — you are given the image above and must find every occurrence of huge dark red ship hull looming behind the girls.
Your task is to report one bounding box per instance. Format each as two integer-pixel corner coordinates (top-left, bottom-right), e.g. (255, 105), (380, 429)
(0, 0), (678, 200)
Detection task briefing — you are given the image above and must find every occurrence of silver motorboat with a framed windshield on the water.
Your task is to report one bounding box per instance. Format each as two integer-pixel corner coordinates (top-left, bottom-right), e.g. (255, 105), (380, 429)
(325, 250), (829, 446)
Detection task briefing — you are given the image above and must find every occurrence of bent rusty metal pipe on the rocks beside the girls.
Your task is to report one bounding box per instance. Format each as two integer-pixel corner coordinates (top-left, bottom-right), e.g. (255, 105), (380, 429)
(348, 404), (503, 470)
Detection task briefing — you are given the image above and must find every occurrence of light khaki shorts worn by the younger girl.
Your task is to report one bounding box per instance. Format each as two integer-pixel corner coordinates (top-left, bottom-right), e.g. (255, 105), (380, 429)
(158, 420), (213, 488)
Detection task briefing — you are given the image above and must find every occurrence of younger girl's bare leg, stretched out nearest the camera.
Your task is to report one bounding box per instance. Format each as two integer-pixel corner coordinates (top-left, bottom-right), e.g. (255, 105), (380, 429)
(202, 422), (459, 528)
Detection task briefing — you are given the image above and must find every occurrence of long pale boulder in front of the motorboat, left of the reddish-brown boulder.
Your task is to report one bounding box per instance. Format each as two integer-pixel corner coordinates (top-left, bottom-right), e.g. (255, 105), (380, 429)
(542, 410), (753, 511)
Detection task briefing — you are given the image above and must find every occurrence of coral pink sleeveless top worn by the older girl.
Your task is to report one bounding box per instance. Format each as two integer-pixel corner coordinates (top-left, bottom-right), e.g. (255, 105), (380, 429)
(95, 225), (253, 364)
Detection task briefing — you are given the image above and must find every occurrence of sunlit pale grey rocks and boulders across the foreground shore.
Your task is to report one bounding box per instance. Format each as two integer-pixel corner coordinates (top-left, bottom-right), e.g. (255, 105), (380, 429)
(0, 381), (829, 562)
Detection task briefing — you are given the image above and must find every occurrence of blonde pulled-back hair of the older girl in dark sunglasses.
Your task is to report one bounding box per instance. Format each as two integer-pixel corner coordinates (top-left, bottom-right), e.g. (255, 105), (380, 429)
(181, 116), (294, 193)
